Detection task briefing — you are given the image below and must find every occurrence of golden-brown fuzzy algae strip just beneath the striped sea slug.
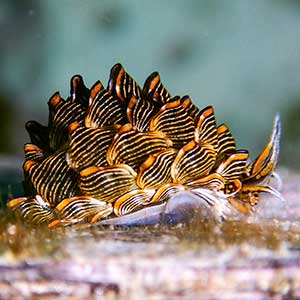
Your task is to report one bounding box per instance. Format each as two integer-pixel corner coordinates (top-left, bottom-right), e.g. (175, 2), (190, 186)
(0, 204), (300, 260)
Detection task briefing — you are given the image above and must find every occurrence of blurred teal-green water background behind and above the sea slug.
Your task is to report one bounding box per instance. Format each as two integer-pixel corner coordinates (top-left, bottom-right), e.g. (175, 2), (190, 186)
(0, 0), (300, 168)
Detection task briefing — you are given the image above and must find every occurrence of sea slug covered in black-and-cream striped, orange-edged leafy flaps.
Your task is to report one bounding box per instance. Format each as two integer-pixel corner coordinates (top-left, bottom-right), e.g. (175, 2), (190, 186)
(8, 64), (281, 227)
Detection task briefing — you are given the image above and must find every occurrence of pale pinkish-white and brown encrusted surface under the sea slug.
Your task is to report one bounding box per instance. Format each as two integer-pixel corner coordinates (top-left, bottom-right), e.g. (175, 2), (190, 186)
(0, 171), (300, 300)
